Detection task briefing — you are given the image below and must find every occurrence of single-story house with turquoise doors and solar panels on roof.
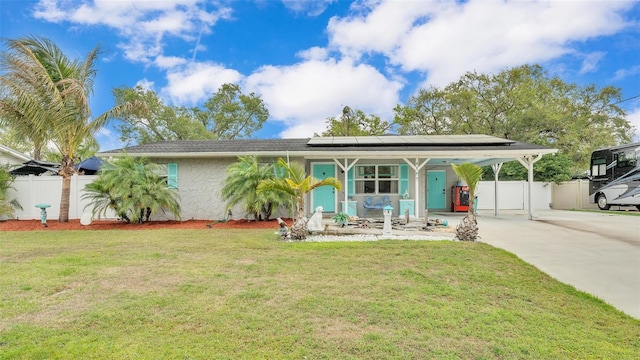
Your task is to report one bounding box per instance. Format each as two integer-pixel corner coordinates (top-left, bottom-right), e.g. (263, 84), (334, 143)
(97, 135), (557, 220)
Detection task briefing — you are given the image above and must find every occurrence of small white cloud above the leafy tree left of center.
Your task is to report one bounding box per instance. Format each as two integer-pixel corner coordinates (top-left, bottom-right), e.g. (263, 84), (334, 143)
(161, 62), (242, 105)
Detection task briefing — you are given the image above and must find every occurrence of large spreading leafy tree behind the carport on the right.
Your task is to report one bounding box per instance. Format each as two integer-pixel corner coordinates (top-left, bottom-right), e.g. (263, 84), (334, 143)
(394, 65), (631, 181)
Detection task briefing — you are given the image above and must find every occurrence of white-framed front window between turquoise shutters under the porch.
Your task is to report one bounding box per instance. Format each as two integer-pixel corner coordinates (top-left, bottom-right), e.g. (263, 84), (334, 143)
(355, 165), (398, 194)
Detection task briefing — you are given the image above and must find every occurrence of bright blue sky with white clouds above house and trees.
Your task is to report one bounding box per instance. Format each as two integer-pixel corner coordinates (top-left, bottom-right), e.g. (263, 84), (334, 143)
(0, 0), (640, 150)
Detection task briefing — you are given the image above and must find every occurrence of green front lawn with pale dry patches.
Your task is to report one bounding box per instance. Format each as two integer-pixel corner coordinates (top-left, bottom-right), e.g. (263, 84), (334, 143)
(0, 228), (640, 359)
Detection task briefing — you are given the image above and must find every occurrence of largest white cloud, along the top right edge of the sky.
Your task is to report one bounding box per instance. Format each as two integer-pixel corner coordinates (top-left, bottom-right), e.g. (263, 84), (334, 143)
(328, 0), (633, 85)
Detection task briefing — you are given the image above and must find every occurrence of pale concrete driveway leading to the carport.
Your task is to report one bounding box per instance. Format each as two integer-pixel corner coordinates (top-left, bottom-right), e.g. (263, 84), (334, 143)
(468, 210), (640, 318)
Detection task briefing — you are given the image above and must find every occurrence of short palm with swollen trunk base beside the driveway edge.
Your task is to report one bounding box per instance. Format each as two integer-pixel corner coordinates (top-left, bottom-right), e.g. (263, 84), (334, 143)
(451, 163), (482, 241)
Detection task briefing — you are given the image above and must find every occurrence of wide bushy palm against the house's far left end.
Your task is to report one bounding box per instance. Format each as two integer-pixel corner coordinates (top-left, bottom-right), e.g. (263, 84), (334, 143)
(82, 156), (180, 223)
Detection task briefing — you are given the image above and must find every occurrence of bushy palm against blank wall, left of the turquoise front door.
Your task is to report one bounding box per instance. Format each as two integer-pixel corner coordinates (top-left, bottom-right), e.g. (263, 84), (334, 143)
(222, 156), (293, 220)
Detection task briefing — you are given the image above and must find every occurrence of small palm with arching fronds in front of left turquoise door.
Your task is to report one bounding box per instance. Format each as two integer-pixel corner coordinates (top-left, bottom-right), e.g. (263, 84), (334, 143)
(258, 158), (342, 240)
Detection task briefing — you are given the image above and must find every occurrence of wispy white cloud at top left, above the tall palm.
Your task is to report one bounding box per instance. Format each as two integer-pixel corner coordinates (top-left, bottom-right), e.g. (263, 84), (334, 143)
(34, 0), (231, 64)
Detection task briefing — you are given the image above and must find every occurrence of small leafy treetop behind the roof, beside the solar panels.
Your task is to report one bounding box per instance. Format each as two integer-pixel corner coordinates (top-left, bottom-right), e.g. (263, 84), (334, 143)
(322, 106), (392, 136)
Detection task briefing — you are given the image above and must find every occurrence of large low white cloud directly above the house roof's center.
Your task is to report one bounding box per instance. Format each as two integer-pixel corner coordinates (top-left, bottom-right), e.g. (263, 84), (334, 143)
(245, 59), (402, 137)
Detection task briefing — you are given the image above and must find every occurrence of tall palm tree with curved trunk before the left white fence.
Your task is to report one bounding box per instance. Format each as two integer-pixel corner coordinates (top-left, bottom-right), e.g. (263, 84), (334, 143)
(0, 36), (142, 222)
